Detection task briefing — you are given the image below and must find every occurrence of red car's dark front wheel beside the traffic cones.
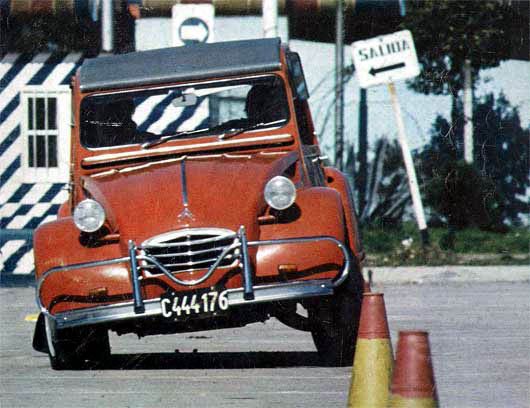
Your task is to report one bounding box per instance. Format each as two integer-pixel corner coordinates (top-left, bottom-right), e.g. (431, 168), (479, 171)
(309, 270), (363, 367)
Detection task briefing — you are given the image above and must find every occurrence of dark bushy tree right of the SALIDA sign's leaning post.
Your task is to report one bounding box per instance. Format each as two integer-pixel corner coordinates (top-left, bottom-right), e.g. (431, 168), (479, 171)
(418, 94), (530, 230)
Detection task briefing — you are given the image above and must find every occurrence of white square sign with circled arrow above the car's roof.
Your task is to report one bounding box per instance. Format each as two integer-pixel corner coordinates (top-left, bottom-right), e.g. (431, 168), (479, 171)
(172, 4), (215, 46)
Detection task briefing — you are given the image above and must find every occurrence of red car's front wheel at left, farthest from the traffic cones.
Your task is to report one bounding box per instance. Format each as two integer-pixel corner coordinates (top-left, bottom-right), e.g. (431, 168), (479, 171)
(48, 318), (110, 370)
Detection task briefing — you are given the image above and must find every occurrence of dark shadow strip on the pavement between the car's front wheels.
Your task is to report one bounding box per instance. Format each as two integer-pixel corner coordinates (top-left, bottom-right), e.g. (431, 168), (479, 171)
(92, 351), (323, 370)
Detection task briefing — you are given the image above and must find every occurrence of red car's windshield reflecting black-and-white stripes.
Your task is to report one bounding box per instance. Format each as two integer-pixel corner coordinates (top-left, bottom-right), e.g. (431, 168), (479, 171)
(81, 75), (289, 148)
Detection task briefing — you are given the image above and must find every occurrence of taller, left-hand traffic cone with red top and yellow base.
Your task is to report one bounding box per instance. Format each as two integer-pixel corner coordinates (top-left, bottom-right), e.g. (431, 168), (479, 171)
(348, 293), (394, 407)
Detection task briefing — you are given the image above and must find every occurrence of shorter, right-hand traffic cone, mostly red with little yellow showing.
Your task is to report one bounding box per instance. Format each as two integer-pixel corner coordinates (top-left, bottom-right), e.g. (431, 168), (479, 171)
(390, 331), (438, 408)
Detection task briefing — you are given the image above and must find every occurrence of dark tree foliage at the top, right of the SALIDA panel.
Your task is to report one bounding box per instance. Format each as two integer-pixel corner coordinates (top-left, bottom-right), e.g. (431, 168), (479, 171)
(402, 0), (528, 95)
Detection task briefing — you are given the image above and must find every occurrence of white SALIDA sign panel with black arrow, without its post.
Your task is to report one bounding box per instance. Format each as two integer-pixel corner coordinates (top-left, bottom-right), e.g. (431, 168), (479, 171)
(352, 30), (420, 88)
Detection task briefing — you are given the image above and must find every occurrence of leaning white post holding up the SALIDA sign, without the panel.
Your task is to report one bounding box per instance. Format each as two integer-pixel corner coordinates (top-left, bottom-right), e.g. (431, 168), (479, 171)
(388, 82), (429, 246)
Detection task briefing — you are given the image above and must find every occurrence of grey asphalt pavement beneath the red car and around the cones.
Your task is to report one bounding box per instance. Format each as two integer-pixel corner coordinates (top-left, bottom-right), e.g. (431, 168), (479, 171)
(0, 280), (530, 408)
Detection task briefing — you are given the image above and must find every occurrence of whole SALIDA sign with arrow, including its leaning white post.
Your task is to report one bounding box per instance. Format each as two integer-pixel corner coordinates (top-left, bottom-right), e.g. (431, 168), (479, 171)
(352, 30), (429, 246)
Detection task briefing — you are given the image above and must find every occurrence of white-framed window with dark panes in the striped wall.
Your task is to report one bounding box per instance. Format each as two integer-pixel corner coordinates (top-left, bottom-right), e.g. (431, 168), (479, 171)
(21, 86), (71, 183)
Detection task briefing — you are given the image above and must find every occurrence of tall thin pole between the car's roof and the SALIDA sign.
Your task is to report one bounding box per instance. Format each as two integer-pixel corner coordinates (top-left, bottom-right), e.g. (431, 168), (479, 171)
(335, 0), (344, 171)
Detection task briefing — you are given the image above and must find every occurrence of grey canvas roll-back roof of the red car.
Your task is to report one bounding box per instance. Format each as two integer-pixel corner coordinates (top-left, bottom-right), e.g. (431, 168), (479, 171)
(79, 38), (280, 92)
